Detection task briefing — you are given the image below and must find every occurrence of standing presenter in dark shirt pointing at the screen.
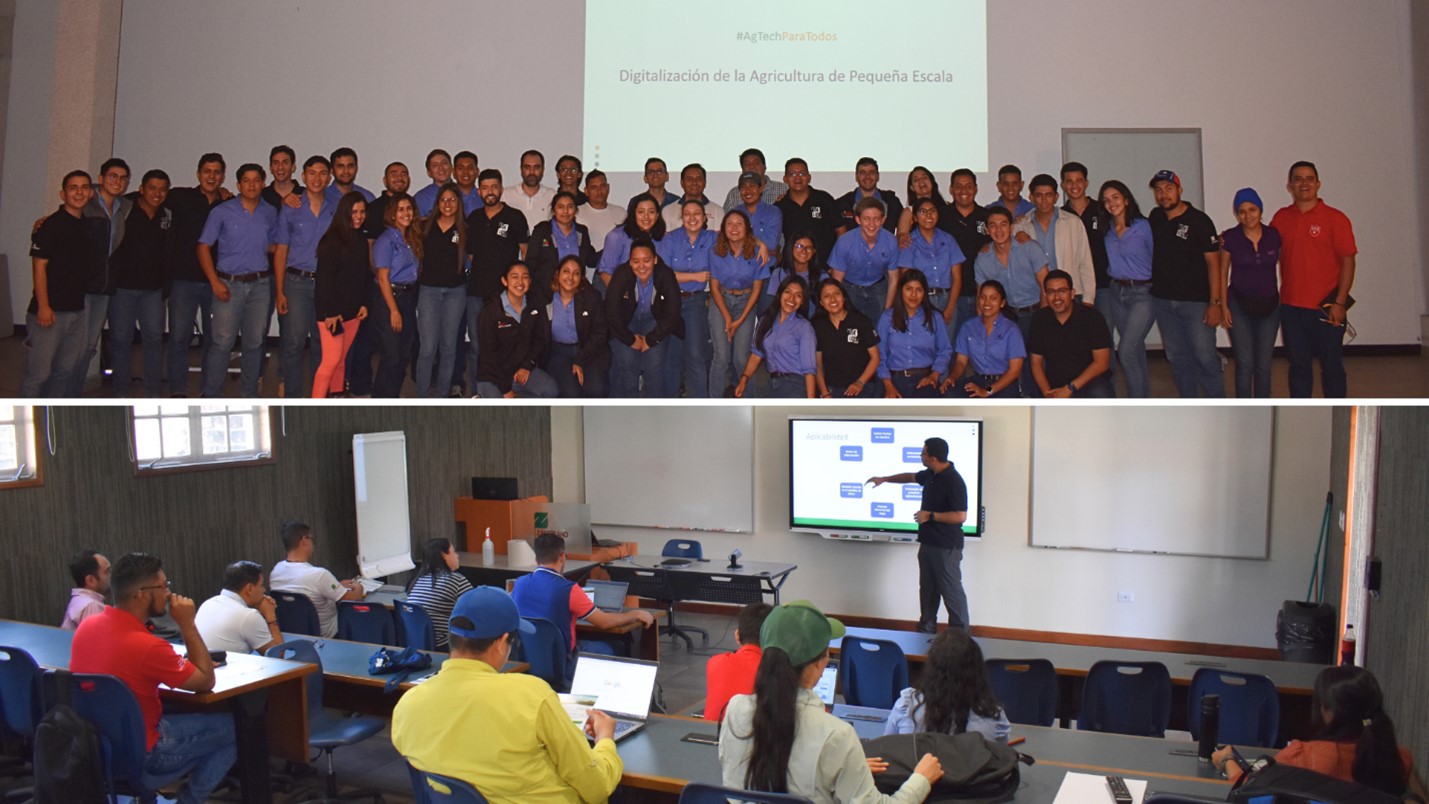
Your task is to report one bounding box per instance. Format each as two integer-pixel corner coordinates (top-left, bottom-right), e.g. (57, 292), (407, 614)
(867, 438), (969, 634)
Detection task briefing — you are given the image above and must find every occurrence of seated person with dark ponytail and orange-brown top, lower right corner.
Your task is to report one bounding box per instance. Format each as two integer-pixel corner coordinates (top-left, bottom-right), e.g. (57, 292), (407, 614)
(1210, 665), (1429, 800)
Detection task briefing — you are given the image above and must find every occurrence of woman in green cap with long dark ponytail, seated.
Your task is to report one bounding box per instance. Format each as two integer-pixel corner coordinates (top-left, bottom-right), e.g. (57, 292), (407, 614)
(719, 600), (943, 804)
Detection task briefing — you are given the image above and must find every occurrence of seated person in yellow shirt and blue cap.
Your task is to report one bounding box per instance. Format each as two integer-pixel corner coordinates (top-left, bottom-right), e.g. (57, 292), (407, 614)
(392, 587), (624, 804)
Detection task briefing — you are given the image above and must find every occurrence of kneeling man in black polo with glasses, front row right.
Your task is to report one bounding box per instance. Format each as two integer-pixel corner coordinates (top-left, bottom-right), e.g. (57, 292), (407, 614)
(1027, 270), (1116, 400)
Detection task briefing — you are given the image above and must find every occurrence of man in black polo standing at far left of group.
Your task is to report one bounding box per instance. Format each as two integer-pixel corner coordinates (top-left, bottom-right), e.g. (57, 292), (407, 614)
(20, 170), (94, 398)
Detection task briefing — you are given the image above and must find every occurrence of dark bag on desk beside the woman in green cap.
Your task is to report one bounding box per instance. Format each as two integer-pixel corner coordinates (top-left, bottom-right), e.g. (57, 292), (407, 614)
(863, 731), (1035, 804)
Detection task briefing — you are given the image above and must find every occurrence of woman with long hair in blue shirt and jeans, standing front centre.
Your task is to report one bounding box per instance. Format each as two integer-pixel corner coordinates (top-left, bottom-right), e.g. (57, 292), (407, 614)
(709, 207), (769, 398)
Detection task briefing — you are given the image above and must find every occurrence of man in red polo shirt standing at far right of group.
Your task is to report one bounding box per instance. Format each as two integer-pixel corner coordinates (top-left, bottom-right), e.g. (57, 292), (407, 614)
(1270, 161), (1358, 398)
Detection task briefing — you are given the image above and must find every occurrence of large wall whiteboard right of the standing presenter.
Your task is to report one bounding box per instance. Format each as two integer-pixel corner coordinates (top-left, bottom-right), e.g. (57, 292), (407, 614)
(1029, 406), (1275, 558)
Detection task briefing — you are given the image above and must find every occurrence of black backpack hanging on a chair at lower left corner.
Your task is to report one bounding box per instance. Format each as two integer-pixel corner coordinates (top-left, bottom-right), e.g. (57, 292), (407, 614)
(34, 670), (109, 804)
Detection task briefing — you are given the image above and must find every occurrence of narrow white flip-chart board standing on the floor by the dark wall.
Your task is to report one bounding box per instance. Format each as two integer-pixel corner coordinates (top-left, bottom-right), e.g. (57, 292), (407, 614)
(353, 431), (416, 578)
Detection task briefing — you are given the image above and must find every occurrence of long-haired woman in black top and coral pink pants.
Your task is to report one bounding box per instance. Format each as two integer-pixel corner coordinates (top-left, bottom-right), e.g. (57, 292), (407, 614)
(313, 190), (372, 400)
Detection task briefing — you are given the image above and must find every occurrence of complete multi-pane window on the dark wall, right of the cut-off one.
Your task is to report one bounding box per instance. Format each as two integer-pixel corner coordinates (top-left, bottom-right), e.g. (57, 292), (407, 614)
(133, 403), (273, 473)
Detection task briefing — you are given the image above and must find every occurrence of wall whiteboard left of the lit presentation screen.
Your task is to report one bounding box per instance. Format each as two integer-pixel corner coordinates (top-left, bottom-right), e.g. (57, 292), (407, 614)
(584, 406), (755, 533)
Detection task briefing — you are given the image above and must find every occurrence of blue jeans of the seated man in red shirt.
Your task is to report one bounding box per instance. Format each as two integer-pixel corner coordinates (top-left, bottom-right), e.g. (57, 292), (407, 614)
(143, 713), (239, 804)
